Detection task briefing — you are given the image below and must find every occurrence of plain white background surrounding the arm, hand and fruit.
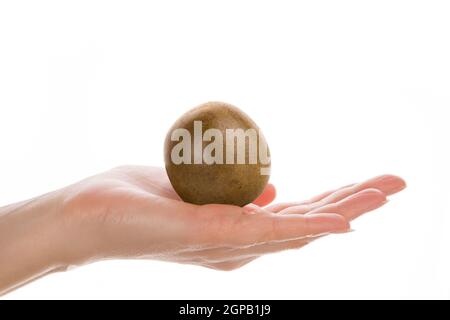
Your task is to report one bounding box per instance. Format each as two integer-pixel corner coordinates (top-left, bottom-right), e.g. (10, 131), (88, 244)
(0, 0), (450, 299)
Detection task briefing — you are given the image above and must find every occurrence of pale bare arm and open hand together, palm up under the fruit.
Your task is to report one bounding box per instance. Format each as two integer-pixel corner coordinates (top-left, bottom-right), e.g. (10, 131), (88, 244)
(0, 166), (406, 295)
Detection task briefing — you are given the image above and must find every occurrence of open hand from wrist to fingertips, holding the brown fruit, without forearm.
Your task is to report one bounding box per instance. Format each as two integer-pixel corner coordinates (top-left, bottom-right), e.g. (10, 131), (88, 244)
(59, 166), (405, 270)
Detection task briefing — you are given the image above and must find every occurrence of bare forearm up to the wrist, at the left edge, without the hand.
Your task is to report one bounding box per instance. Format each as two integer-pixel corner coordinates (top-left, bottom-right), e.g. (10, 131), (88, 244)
(0, 192), (66, 295)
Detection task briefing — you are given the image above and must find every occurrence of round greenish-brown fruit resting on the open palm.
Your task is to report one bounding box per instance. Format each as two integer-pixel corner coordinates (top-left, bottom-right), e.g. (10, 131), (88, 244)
(164, 102), (270, 206)
